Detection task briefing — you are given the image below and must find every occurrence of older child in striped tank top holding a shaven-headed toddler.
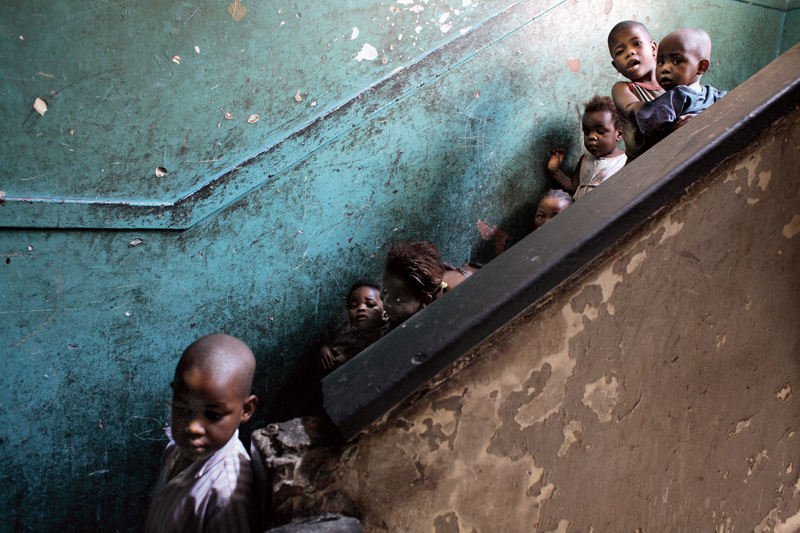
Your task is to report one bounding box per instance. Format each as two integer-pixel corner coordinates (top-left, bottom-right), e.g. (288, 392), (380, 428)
(608, 20), (664, 161)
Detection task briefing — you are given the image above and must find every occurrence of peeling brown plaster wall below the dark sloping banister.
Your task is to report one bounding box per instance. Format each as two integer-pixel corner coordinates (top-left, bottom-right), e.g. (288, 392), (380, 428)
(333, 108), (800, 533)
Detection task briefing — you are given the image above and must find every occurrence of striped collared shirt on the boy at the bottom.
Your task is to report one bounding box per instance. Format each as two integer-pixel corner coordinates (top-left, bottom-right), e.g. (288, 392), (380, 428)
(145, 428), (253, 533)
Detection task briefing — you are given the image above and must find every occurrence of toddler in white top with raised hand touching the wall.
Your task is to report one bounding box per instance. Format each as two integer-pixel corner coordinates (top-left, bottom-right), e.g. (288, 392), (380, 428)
(547, 96), (627, 200)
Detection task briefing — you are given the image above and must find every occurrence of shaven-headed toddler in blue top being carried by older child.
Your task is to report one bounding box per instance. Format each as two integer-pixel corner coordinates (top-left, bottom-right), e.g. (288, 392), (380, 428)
(636, 28), (728, 152)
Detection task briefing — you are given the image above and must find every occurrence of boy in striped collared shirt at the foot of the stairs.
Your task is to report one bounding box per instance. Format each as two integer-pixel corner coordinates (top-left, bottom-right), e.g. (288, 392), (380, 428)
(145, 334), (258, 533)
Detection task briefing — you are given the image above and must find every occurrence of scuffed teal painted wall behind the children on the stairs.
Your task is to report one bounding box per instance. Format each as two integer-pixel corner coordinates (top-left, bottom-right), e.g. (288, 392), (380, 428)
(0, 0), (797, 531)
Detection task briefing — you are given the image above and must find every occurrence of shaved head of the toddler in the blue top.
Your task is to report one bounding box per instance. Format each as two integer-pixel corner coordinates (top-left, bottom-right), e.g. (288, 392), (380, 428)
(656, 28), (711, 91)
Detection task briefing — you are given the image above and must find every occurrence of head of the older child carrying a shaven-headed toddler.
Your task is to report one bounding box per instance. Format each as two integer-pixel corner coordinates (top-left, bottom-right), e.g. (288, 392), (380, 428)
(608, 20), (657, 81)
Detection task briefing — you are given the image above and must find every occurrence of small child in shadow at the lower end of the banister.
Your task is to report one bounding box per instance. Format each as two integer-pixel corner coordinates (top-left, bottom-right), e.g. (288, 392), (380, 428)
(319, 279), (389, 373)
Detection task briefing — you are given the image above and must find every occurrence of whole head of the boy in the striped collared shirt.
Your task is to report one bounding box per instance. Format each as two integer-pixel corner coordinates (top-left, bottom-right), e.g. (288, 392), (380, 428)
(171, 334), (258, 461)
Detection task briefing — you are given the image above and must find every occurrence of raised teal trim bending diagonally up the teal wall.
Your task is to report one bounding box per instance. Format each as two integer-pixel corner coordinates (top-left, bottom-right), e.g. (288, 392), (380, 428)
(0, 0), (566, 229)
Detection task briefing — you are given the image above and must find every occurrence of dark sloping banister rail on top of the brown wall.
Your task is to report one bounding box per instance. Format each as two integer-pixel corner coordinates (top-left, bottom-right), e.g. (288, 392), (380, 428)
(323, 44), (800, 439)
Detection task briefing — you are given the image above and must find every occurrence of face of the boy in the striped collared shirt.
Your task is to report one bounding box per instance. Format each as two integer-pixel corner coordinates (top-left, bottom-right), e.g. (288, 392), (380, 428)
(171, 366), (257, 461)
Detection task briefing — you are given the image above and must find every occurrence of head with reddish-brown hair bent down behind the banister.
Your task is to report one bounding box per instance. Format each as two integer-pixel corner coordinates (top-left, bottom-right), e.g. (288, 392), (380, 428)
(381, 241), (444, 327)
